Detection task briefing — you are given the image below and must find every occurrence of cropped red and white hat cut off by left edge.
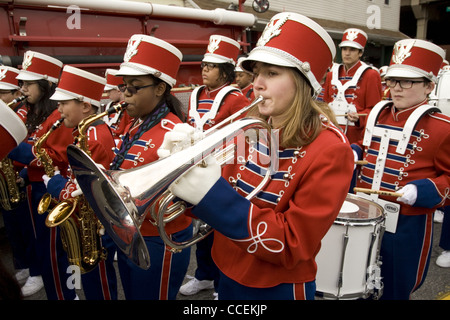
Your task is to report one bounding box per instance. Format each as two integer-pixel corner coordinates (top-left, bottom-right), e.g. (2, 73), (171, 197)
(0, 100), (27, 159)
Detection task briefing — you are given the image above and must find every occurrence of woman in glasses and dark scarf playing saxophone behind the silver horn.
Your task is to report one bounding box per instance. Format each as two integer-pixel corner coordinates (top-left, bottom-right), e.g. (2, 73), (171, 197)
(110, 34), (192, 300)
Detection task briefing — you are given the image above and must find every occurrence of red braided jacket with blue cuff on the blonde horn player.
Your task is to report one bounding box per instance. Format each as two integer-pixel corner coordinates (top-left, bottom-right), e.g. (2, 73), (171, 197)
(192, 120), (354, 288)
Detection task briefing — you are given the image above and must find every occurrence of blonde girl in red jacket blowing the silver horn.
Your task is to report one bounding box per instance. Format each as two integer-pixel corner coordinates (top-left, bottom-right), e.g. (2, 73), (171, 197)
(163, 12), (353, 300)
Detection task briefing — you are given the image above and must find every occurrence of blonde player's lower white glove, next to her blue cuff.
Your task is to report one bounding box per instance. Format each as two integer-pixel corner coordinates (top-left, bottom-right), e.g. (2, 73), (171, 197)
(169, 156), (221, 205)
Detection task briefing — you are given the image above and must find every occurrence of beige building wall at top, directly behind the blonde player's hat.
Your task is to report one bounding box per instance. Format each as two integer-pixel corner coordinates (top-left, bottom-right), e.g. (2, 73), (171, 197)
(192, 0), (408, 67)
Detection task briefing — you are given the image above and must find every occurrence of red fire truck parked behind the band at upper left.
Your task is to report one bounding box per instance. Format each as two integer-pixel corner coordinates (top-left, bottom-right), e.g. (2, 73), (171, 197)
(0, 0), (256, 87)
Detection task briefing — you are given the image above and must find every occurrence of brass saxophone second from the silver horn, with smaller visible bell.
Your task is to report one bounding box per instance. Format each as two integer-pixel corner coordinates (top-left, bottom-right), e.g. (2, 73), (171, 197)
(34, 118), (64, 214)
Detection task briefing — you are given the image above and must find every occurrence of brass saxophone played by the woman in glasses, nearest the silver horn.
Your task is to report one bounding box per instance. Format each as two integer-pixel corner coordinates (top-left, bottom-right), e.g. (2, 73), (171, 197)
(45, 103), (126, 273)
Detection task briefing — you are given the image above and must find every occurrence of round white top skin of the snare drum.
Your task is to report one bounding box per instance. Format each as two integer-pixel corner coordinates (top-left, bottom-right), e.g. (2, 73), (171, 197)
(336, 194), (384, 223)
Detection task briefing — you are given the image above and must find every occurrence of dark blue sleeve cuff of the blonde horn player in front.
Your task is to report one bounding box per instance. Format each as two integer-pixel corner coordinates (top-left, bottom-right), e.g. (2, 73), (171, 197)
(192, 177), (250, 239)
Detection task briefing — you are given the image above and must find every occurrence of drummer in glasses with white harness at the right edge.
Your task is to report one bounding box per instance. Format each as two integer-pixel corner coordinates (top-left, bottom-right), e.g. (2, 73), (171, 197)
(352, 39), (450, 300)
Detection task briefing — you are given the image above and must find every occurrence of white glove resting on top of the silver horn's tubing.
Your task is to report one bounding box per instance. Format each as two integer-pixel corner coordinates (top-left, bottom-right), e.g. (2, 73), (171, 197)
(157, 123), (203, 159)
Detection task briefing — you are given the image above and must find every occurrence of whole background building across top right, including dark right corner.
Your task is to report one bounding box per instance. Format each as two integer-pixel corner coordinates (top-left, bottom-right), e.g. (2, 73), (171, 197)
(192, 0), (450, 67)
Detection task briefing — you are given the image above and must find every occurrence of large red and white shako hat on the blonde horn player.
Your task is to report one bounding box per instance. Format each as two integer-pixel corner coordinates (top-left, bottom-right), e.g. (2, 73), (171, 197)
(241, 12), (336, 95)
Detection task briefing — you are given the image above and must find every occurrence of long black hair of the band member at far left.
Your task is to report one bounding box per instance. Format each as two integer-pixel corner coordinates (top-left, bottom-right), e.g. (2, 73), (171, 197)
(25, 80), (58, 133)
